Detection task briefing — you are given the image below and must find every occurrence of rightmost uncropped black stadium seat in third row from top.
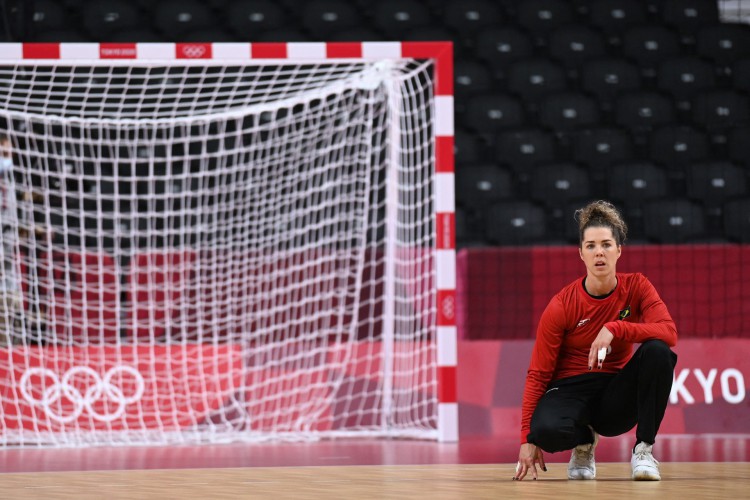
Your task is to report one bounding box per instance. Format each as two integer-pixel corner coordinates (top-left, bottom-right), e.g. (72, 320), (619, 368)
(656, 56), (716, 101)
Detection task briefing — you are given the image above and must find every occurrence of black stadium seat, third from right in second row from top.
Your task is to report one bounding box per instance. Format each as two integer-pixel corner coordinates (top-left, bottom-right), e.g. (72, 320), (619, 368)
(549, 24), (605, 69)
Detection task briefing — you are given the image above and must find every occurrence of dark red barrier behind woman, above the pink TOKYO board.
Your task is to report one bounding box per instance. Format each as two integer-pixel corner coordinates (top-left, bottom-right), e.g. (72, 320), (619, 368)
(456, 245), (750, 339)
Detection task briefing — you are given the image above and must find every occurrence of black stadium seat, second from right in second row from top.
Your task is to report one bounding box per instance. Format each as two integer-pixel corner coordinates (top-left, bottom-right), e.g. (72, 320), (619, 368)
(622, 24), (681, 70)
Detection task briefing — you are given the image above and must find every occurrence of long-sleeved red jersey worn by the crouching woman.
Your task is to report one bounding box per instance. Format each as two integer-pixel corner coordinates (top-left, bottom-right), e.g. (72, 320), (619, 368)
(521, 273), (677, 443)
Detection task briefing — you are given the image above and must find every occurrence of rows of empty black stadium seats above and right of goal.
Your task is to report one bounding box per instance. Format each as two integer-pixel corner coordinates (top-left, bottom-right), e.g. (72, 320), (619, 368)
(8, 0), (750, 249)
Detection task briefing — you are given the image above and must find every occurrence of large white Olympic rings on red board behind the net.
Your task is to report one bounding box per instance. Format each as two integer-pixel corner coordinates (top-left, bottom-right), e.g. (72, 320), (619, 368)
(20, 365), (145, 424)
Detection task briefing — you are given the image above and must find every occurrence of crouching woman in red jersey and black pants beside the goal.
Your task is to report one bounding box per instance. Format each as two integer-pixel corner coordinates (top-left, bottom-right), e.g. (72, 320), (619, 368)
(513, 201), (677, 481)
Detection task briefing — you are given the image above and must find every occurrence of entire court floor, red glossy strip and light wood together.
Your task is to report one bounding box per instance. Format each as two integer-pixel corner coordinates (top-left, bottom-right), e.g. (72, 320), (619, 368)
(0, 434), (750, 500)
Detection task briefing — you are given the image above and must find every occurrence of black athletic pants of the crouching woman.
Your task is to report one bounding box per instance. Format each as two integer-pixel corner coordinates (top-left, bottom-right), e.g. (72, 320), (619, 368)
(527, 340), (677, 453)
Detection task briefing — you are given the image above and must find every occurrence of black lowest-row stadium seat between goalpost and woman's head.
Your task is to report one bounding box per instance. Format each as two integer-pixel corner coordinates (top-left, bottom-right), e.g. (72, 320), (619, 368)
(485, 201), (547, 245)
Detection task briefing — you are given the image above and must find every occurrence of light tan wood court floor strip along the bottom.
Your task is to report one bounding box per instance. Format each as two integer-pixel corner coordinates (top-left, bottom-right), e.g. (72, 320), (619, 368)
(0, 462), (750, 500)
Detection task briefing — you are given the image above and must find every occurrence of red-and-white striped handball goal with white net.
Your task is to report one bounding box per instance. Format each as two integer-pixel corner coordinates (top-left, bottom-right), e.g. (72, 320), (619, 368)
(0, 42), (458, 447)
